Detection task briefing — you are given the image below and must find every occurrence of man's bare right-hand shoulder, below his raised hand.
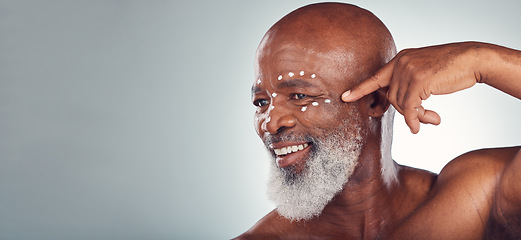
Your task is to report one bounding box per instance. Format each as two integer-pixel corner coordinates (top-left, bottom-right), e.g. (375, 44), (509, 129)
(391, 147), (520, 239)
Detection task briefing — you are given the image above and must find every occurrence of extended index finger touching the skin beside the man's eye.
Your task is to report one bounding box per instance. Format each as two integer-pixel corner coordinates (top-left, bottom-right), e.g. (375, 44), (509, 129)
(342, 59), (394, 102)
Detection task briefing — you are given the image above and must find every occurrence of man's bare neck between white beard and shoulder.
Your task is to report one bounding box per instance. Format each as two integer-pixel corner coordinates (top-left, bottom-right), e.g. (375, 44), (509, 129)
(308, 134), (406, 238)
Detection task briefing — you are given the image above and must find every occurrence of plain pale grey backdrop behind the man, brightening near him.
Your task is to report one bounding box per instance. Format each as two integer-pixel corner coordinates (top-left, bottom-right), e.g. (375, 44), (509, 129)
(0, 0), (521, 240)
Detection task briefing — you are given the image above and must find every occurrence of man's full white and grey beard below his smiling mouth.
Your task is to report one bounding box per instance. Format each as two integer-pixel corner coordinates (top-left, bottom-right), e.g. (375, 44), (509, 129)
(268, 126), (361, 221)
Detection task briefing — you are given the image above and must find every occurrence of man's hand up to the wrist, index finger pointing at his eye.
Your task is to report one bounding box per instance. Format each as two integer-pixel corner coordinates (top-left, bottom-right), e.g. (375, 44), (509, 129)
(342, 42), (486, 133)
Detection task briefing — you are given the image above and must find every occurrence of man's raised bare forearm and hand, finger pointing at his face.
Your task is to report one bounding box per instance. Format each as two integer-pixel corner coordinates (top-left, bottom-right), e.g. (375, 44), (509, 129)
(342, 42), (521, 133)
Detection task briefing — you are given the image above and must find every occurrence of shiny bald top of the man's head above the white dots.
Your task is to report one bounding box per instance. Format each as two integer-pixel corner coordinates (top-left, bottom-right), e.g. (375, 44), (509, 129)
(256, 3), (396, 90)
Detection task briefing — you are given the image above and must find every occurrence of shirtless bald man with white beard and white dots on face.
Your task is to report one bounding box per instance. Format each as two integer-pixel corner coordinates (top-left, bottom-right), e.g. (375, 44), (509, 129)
(237, 3), (521, 239)
